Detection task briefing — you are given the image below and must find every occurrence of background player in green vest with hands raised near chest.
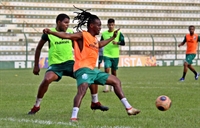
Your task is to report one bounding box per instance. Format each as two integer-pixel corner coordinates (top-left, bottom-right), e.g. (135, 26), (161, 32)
(101, 19), (125, 92)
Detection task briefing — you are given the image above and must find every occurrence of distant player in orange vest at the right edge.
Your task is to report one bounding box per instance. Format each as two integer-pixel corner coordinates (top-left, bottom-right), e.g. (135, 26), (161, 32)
(178, 25), (200, 81)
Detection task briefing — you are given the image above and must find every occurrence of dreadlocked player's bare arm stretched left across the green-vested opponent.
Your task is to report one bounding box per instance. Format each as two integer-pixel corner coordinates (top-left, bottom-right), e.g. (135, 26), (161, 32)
(43, 28), (83, 40)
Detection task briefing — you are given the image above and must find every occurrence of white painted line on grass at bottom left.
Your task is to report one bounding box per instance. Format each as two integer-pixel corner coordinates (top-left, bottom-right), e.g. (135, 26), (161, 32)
(0, 117), (77, 127)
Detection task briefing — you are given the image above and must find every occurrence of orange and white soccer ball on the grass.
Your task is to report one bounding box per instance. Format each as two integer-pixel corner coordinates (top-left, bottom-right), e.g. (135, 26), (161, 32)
(156, 95), (171, 111)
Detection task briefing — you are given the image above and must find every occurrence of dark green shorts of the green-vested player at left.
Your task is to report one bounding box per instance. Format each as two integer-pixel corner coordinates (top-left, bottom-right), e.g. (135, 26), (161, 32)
(46, 60), (74, 81)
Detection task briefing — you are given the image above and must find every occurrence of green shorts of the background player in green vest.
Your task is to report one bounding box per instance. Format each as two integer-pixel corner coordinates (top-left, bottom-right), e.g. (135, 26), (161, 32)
(103, 56), (119, 70)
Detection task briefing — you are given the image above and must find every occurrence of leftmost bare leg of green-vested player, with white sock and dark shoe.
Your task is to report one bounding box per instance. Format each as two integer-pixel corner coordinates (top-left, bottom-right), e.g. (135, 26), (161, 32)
(28, 71), (58, 114)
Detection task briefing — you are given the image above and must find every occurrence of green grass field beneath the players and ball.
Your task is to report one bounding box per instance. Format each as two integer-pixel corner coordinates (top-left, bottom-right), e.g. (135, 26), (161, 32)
(0, 66), (200, 128)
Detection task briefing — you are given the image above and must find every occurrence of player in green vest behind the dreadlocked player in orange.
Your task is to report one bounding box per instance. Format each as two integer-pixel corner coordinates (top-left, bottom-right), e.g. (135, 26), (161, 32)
(28, 14), (108, 114)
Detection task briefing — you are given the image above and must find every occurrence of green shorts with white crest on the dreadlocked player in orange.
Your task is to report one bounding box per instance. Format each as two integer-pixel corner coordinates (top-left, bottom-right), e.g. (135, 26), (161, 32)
(74, 68), (109, 86)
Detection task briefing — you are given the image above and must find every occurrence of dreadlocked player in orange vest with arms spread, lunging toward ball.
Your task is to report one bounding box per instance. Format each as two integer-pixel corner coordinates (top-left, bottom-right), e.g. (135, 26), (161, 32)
(44, 6), (140, 122)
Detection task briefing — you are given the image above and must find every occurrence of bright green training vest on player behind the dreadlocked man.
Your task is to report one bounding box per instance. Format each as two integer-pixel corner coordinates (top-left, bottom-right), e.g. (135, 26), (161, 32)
(48, 28), (74, 65)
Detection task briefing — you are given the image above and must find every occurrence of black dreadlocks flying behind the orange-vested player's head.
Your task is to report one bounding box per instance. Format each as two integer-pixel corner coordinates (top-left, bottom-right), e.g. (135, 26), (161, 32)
(73, 6), (99, 31)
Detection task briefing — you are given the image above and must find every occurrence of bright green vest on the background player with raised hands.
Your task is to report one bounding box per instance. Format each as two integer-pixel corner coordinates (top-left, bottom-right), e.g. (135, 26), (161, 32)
(102, 30), (120, 58)
